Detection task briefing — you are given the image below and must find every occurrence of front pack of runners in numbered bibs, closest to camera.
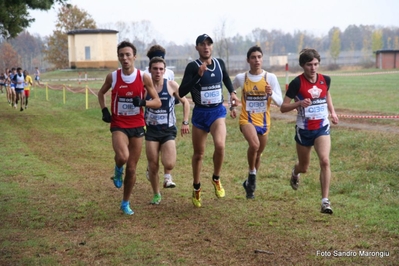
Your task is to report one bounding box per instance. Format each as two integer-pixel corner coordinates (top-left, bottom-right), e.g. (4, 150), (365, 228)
(98, 34), (338, 215)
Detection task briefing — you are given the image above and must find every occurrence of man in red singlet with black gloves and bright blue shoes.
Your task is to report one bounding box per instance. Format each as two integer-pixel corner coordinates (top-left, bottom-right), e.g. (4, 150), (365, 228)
(98, 41), (161, 215)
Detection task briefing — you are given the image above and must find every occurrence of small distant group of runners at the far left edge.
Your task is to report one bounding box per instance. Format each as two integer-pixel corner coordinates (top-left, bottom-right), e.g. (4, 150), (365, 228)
(0, 67), (40, 111)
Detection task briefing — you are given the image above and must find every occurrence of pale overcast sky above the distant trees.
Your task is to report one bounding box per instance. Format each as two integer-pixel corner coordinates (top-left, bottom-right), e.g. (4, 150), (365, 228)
(28, 0), (399, 45)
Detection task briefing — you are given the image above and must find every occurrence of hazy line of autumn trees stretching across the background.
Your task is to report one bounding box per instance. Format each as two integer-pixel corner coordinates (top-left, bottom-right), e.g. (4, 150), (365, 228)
(0, 3), (399, 69)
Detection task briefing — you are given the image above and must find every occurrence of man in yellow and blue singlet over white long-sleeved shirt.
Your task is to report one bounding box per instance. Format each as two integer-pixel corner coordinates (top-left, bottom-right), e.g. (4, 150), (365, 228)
(230, 46), (283, 199)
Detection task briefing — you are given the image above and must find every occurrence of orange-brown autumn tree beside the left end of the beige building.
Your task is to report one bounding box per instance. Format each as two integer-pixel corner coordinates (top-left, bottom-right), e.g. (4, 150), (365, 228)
(43, 5), (97, 68)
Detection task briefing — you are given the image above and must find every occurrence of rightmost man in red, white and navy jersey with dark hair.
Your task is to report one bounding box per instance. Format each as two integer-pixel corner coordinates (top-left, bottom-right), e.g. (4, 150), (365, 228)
(280, 49), (338, 214)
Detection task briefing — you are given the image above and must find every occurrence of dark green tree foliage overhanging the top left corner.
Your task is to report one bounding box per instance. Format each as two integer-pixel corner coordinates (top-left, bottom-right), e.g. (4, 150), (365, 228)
(0, 0), (68, 39)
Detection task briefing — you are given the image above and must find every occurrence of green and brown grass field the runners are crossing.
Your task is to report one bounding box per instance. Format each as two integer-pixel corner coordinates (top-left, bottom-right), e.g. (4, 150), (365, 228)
(0, 69), (399, 265)
